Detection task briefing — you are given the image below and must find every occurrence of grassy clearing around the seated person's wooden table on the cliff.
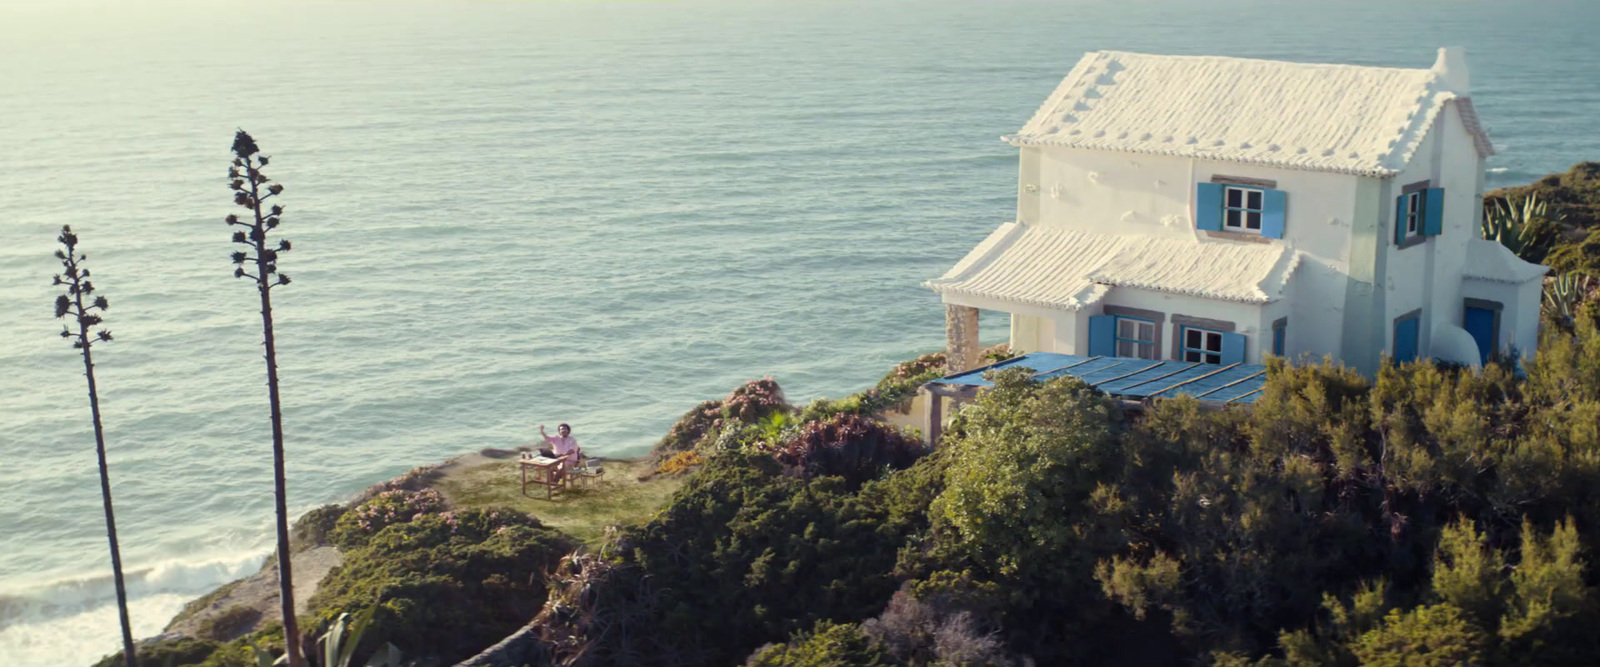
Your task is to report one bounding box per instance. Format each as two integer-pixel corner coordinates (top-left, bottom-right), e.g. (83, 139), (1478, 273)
(432, 456), (683, 547)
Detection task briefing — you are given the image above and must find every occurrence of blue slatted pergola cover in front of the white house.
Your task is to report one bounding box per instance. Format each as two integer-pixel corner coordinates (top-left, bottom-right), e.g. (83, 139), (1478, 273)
(928, 352), (1267, 403)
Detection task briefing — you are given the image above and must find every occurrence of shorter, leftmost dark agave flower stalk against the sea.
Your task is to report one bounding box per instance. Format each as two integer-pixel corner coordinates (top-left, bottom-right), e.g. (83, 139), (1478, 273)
(54, 226), (138, 667)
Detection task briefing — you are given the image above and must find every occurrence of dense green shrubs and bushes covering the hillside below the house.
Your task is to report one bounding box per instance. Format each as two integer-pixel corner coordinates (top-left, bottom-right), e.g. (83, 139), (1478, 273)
(118, 165), (1600, 667)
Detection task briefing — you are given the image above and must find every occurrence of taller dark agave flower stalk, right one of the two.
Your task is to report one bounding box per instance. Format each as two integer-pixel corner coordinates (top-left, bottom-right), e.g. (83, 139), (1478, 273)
(224, 130), (306, 667)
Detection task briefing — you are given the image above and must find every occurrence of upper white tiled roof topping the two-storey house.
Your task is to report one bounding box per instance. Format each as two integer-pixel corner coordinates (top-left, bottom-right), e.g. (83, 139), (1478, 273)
(1005, 51), (1494, 176)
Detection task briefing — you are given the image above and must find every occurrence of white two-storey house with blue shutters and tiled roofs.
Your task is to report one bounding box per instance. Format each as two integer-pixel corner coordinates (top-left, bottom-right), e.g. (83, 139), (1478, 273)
(926, 48), (1546, 374)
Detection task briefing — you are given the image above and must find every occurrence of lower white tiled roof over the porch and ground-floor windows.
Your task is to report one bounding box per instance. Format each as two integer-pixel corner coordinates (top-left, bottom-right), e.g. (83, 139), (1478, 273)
(925, 222), (1299, 310)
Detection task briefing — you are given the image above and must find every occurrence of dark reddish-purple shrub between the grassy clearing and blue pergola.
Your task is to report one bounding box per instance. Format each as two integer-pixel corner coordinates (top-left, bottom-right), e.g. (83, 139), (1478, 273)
(773, 414), (928, 488)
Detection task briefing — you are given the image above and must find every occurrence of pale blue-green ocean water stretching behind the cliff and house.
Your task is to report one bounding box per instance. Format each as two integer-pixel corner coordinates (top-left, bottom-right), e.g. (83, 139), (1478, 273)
(0, 0), (1600, 667)
